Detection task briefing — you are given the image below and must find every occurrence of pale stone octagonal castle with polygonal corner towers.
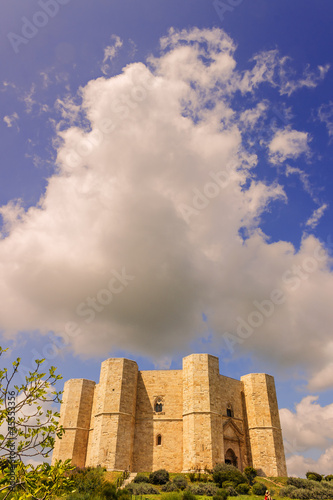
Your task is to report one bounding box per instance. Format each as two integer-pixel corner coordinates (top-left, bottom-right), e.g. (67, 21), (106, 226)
(52, 354), (287, 476)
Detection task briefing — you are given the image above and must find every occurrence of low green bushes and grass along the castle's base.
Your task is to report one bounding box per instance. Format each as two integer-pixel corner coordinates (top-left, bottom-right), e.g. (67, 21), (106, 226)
(0, 464), (333, 500)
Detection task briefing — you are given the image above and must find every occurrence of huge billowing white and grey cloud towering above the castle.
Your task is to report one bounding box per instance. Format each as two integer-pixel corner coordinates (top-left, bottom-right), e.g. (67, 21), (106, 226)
(0, 29), (333, 384)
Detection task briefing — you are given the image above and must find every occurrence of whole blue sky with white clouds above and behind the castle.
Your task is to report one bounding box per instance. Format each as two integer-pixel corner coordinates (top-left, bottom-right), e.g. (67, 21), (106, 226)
(0, 0), (333, 475)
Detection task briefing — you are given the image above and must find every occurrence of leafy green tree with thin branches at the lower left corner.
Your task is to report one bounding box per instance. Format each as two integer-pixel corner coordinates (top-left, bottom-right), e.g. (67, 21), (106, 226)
(0, 347), (73, 500)
